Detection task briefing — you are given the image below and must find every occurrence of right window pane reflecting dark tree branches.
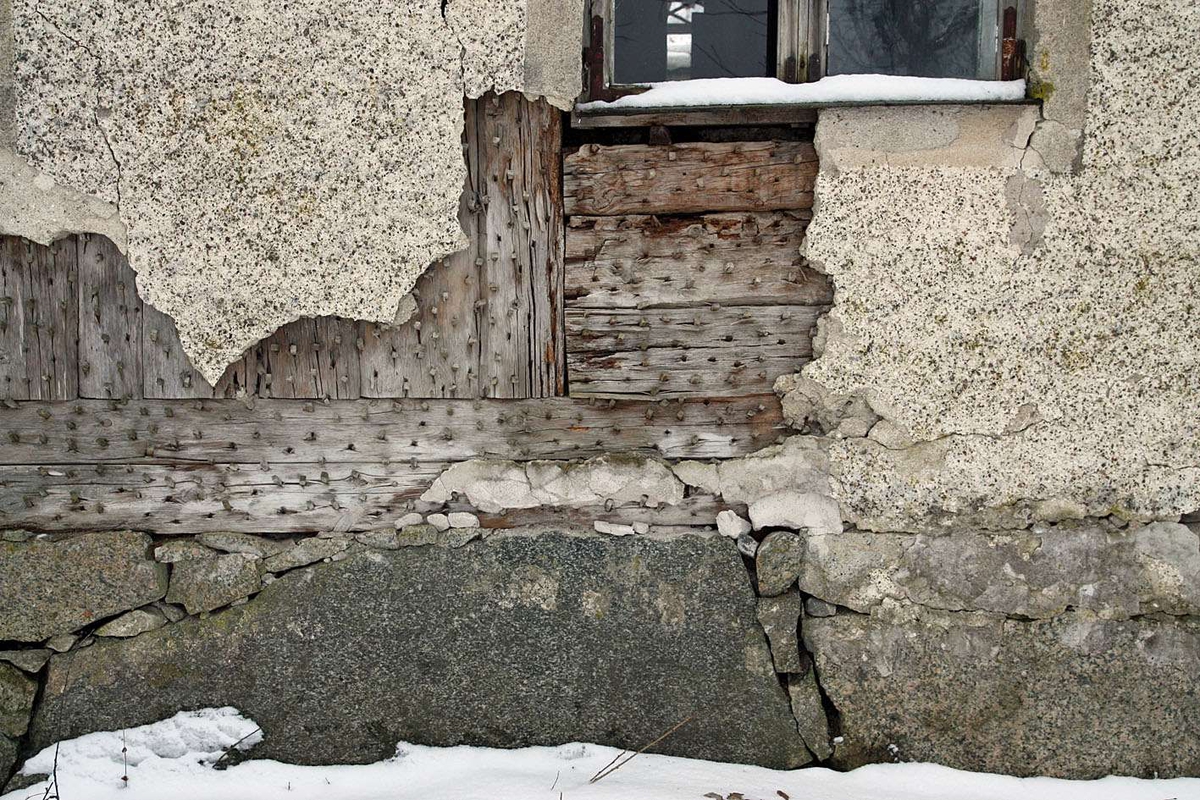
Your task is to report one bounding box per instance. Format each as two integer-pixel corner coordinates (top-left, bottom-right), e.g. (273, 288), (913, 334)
(827, 0), (998, 80)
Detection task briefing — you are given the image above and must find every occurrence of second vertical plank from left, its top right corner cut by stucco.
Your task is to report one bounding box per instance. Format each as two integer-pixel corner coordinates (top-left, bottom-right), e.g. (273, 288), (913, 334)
(78, 234), (142, 398)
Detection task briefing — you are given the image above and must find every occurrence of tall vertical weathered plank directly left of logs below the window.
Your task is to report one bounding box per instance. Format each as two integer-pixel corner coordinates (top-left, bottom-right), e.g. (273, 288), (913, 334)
(478, 92), (564, 397)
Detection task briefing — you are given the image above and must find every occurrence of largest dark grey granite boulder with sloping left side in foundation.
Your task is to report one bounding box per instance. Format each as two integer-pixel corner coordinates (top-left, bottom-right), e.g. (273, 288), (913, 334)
(31, 531), (809, 768)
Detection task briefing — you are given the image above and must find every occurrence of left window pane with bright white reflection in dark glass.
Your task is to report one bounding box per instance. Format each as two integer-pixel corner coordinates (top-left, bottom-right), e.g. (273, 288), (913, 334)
(612, 0), (775, 84)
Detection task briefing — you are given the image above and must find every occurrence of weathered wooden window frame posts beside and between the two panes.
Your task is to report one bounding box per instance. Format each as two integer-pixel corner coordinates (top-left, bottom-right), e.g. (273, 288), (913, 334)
(584, 0), (1024, 101)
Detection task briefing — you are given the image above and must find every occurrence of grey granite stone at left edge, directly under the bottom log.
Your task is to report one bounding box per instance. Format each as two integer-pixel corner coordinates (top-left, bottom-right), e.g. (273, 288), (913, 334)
(0, 531), (167, 642)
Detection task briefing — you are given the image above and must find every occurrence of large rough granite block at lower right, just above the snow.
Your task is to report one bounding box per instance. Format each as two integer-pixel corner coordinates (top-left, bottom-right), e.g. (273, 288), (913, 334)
(804, 602), (1200, 778)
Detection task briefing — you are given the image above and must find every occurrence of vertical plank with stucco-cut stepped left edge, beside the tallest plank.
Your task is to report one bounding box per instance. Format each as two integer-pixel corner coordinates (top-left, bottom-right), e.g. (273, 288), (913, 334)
(359, 100), (482, 398)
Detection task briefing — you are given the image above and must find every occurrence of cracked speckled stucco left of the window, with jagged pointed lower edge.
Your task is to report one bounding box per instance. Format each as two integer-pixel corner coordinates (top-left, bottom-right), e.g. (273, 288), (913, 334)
(0, 0), (582, 381)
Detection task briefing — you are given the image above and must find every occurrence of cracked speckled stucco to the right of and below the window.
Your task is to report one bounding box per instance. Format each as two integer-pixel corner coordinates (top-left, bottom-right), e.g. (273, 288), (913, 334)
(778, 0), (1200, 531)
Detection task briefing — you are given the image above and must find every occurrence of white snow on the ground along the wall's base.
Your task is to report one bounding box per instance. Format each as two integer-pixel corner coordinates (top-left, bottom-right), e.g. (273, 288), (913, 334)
(0, 708), (1200, 800)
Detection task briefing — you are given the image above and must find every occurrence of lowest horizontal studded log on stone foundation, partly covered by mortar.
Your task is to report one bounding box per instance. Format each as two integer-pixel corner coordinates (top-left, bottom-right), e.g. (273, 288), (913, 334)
(0, 463), (726, 535)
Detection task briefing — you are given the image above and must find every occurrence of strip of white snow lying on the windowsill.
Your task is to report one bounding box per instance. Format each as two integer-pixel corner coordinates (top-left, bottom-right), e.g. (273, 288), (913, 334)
(576, 76), (1025, 112)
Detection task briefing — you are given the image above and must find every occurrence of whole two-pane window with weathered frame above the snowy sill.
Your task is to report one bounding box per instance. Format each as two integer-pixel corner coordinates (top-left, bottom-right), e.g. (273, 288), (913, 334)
(588, 0), (1016, 100)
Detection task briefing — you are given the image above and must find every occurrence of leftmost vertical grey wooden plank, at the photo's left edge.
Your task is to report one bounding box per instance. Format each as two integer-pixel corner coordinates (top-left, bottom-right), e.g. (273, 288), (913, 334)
(0, 236), (79, 401)
